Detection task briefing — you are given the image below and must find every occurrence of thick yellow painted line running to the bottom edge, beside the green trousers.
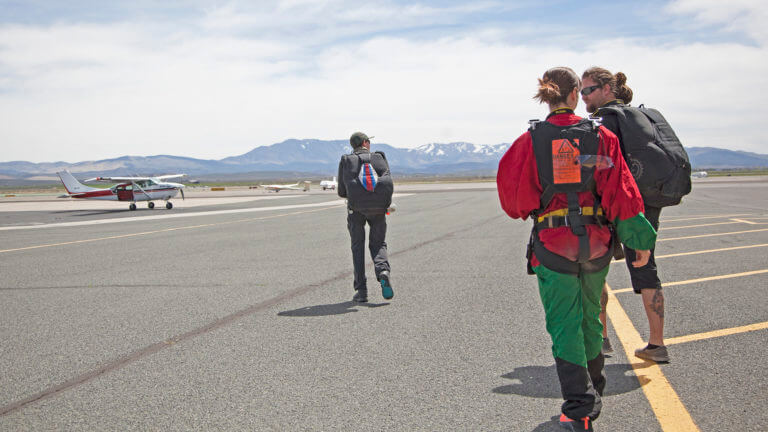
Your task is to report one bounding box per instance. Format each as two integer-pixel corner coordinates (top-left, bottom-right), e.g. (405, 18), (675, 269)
(607, 293), (700, 432)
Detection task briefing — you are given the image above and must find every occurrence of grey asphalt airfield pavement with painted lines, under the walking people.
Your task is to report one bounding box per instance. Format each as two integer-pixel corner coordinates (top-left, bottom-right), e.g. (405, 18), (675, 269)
(0, 179), (768, 432)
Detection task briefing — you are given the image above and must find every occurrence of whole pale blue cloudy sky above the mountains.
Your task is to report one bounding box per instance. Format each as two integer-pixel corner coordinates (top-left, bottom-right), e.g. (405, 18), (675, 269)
(0, 0), (768, 162)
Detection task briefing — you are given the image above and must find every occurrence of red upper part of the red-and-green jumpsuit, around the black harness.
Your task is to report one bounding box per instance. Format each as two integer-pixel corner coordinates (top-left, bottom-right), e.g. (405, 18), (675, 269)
(496, 113), (643, 267)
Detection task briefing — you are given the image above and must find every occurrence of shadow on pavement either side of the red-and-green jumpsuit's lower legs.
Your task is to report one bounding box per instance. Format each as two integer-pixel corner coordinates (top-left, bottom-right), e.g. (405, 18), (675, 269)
(493, 363), (644, 398)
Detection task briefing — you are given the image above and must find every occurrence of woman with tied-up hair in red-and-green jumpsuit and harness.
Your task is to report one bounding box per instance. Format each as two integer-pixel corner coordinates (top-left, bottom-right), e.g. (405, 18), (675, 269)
(496, 67), (656, 431)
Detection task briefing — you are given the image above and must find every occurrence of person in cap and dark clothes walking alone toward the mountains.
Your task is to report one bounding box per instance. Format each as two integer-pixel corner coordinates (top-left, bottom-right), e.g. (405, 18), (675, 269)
(337, 132), (395, 303)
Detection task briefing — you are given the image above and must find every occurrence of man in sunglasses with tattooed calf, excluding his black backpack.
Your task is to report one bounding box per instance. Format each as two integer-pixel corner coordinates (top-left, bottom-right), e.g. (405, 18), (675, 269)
(581, 67), (669, 362)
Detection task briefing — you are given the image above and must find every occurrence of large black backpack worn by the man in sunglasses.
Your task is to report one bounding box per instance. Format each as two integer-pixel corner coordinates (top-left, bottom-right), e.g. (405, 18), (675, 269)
(596, 105), (691, 207)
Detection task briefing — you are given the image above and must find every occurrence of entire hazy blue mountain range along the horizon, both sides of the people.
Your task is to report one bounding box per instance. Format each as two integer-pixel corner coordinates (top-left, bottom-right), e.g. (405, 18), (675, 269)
(0, 139), (768, 184)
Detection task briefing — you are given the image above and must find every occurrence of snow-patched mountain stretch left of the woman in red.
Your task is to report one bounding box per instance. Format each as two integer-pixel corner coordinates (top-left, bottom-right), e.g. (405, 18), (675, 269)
(0, 139), (509, 179)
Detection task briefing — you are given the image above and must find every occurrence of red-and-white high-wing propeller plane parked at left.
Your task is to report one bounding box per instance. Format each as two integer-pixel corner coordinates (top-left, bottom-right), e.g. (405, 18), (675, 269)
(56, 170), (186, 210)
